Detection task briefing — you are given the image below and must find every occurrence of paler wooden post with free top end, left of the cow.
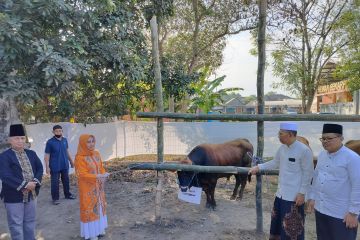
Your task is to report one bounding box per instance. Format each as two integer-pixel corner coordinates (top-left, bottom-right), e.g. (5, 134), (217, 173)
(150, 15), (164, 224)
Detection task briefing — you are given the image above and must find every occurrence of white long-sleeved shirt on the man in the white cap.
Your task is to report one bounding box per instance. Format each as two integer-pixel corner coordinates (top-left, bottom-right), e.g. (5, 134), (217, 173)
(258, 141), (314, 201)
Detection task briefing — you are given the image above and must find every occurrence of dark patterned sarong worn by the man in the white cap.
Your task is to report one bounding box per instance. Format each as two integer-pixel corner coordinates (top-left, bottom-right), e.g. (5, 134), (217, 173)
(269, 197), (305, 240)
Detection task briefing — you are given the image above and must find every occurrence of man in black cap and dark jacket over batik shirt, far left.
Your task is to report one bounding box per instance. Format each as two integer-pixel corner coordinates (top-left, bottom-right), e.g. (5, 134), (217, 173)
(0, 124), (43, 240)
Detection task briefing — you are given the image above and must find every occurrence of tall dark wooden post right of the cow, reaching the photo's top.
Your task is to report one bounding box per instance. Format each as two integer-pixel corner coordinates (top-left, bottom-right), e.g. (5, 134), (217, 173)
(256, 0), (267, 232)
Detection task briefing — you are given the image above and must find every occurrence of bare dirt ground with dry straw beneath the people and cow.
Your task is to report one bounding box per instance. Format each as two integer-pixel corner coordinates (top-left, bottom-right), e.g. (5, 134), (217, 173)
(0, 156), (360, 240)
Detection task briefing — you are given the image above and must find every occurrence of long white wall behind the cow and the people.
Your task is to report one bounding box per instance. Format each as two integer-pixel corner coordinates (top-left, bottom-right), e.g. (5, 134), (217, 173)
(26, 121), (360, 163)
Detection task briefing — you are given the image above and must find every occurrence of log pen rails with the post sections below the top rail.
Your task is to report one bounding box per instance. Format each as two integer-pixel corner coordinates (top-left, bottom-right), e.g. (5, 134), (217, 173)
(131, 112), (360, 232)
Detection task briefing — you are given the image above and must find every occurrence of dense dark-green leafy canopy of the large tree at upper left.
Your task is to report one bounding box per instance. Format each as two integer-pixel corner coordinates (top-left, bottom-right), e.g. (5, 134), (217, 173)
(0, 0), (150, 122)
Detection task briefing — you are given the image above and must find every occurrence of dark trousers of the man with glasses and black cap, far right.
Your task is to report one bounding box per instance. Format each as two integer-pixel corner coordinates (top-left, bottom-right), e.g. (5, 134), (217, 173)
(315, 211), (357, 240)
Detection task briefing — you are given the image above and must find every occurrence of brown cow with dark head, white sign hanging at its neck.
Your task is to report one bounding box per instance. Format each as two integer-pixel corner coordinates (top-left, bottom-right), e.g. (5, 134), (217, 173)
(177, 139), (253, 209)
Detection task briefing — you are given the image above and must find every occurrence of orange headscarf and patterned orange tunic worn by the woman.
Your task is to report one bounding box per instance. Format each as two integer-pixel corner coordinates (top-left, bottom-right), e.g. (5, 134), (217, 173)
(75, 135), (106, 223)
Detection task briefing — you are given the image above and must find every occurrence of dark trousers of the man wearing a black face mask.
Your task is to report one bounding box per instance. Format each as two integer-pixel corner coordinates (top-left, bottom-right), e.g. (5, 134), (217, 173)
(50, 169), (71, 200)
